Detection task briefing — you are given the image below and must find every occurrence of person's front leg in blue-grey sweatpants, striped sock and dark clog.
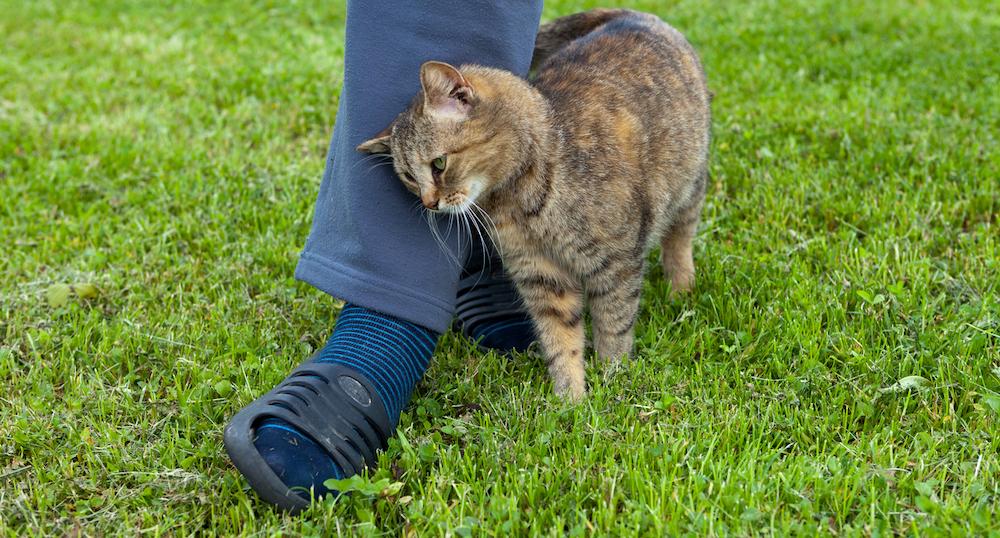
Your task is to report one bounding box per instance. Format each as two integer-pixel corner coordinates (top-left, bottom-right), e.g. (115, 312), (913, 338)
(226, 0), (542, 507)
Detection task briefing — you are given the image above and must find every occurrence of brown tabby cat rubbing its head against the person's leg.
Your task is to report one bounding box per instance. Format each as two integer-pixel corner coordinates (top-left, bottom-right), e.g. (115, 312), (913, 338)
(358, 9), (711, 400)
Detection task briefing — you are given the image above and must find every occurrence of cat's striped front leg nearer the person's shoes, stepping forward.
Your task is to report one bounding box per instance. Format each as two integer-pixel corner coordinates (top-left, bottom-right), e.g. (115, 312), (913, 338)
(507, 256), (587, 400)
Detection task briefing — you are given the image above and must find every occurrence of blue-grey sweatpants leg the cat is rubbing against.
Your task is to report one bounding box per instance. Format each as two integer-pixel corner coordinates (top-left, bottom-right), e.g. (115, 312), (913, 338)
(295, 0), (542, 332)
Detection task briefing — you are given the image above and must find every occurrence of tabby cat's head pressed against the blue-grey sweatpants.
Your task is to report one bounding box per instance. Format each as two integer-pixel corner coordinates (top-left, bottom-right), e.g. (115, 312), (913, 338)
(357, 62), (534, 213)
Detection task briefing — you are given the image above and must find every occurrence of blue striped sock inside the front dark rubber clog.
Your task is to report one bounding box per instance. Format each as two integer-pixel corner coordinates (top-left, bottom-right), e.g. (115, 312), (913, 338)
(254, 304), (438, 496)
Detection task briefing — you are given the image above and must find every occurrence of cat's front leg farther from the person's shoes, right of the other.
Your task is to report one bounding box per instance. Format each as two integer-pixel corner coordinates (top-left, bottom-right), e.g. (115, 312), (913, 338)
(587, 259), (644, 365)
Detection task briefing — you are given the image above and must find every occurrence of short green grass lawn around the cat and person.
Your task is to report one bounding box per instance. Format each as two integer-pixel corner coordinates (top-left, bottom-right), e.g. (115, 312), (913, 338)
(0, 0), (1000, 536)
